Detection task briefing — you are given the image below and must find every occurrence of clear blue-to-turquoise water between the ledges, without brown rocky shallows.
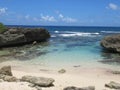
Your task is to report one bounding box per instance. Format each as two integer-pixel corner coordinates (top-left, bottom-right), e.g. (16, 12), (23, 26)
(2, 26), (120, 66)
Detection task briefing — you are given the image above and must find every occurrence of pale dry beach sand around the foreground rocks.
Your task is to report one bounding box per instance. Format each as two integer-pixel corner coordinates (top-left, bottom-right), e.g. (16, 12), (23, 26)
(0, 67), (120, 90)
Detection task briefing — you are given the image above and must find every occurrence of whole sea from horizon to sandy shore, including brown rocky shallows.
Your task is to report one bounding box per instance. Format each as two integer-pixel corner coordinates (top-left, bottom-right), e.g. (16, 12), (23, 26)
(0, 25), (120, 69)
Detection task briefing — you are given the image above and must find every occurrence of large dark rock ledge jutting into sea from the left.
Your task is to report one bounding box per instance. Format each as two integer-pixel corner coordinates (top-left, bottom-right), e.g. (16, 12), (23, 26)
(0, 28), (50, 47)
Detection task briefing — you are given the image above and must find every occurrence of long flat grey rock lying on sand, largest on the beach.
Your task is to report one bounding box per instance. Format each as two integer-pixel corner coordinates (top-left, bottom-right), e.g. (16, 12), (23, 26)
(21, 76), (55, 87)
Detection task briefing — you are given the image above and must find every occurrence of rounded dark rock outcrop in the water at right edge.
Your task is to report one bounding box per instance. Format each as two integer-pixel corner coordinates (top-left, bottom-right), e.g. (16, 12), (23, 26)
(100, 34), (120, 53)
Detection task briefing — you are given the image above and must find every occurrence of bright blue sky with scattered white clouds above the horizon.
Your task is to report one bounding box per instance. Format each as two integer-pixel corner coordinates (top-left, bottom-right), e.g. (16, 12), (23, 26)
(0, 0), (120, 26)
